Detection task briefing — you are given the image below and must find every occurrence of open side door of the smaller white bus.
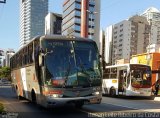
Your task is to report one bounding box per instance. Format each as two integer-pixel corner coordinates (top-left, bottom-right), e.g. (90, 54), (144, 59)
(118, 69), (127, 94)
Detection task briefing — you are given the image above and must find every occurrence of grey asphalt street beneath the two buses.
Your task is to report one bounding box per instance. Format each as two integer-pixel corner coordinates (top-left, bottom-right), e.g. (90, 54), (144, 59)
(0, 86), (160, 118)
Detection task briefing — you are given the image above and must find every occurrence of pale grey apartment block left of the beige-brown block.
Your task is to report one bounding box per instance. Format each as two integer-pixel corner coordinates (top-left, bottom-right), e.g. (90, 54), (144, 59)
(110, 20), (131, 64)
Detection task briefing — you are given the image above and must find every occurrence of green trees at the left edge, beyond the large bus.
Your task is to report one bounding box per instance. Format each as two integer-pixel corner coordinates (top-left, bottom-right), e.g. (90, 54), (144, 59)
(0, 67), (11, 80)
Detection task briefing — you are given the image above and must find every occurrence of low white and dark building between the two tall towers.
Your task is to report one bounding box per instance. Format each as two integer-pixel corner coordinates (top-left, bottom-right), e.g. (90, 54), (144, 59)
(45, 13), (62, 35)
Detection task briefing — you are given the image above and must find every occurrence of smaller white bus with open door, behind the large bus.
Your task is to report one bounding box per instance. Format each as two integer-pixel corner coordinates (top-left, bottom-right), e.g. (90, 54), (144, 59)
(102, 64), (152, 97)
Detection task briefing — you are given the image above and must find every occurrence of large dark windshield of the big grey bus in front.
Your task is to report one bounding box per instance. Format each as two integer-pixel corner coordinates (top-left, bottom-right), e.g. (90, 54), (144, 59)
(42, 40), (101, 87)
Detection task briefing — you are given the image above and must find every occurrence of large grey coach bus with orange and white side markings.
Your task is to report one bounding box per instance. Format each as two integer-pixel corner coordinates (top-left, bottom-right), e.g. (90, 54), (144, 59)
(10, 35), (102, 108)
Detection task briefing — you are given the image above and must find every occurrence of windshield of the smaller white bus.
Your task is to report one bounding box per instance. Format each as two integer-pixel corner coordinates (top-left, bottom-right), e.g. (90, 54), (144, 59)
(130, 65), (151, 88)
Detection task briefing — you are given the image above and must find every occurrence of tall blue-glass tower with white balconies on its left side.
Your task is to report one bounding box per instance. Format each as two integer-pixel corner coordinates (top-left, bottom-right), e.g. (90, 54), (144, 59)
(20, 0), (48, 47)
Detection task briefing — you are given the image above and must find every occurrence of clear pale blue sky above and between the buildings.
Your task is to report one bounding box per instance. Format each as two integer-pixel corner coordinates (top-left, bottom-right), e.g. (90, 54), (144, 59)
(0, 0), (160, 51)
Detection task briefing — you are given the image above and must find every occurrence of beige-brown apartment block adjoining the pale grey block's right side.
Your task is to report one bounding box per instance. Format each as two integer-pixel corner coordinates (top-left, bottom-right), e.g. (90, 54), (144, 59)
(129, 15), (151, 55)
